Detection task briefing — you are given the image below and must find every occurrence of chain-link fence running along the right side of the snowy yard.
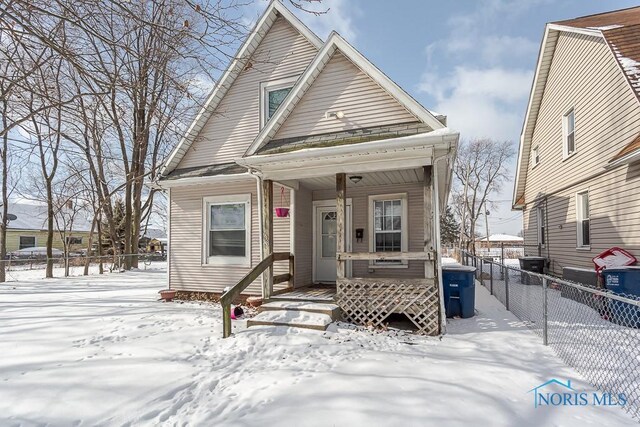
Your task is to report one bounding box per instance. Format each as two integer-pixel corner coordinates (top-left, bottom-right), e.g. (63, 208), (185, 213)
(462, 253), (640, 420)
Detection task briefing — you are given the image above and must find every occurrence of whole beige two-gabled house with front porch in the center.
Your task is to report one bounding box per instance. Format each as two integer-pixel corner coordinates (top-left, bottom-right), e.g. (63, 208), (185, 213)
(158, 1), (458, 333)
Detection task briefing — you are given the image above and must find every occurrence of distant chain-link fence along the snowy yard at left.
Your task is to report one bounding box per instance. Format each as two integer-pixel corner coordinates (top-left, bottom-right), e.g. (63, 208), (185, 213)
(0, 253), (166, 282)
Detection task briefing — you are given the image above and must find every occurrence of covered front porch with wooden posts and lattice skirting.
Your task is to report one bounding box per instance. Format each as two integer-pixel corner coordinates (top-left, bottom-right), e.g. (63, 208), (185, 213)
(222, 130), (457, 335)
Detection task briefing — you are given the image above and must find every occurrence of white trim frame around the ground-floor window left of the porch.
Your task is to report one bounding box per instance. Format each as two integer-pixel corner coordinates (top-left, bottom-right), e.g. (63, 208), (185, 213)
(201, 193), (252, 267)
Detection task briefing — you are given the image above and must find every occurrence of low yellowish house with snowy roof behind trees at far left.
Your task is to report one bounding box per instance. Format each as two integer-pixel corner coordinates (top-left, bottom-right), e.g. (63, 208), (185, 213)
(7, 203), (91, 253)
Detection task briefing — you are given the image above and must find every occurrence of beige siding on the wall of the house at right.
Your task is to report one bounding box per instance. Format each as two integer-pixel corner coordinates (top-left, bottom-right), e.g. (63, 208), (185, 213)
(524, 33), (640, 275)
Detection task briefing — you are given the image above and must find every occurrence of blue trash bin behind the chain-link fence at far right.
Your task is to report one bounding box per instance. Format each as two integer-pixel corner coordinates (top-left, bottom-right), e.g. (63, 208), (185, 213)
(602, 267), (640, 328)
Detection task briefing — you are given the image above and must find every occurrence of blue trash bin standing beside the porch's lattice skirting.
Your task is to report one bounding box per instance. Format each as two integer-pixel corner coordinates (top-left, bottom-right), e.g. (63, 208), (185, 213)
(442, 264), (476, 319)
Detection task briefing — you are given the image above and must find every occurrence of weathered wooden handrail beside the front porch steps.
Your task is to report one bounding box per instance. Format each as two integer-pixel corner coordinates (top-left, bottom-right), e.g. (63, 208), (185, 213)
(220, 252), (294, 338)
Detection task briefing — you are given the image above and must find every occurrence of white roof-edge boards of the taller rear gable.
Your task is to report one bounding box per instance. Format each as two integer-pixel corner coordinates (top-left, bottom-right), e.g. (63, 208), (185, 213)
(161, 0), (323, 176)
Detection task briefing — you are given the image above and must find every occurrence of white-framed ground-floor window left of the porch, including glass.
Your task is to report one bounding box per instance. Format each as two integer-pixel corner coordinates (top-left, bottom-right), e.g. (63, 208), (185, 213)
(203, 194), (251, 265)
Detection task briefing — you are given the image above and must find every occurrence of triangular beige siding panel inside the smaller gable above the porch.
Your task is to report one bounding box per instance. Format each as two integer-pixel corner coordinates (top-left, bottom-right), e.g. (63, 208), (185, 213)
(272, 52), (418, 139)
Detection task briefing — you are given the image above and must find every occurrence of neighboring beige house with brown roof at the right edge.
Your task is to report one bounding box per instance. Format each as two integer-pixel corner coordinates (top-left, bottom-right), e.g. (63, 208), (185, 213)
(513, 7), (640, 275)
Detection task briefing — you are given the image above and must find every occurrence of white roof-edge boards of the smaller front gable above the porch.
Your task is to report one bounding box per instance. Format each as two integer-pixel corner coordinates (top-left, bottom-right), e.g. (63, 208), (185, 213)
(245, 31), (445, 156)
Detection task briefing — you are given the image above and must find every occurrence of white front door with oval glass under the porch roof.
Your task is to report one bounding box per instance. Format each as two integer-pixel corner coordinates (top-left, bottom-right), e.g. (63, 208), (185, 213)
(314, 205), (351, 283)
